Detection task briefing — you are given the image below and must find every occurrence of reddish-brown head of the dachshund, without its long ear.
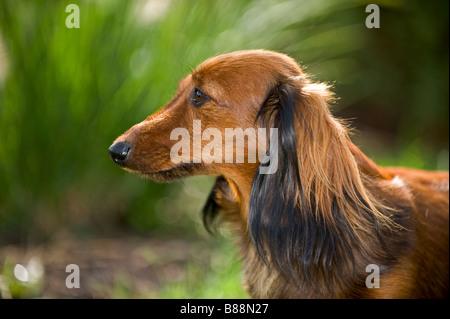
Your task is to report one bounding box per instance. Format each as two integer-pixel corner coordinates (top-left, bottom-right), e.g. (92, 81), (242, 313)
(109, 50), (302, 181)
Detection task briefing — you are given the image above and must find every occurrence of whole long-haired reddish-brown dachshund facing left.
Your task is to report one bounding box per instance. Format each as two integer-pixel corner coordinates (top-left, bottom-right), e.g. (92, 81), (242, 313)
(109, 50), (449, 298)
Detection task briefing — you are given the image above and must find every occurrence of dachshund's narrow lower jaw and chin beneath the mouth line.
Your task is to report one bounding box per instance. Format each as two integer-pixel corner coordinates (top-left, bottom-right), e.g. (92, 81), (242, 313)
(125, 163), (204, 183)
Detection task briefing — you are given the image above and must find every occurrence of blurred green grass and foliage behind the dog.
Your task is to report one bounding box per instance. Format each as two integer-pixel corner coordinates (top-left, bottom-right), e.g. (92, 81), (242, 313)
(0, 0), (449, 297)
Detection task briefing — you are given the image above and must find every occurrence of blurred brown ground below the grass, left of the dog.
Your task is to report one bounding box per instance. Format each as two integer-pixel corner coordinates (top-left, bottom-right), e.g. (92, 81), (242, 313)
(0, 237), (211, 298)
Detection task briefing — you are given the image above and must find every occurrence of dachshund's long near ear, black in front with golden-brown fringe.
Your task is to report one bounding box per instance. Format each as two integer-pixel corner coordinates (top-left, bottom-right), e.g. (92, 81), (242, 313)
(249, 77), (400, 279)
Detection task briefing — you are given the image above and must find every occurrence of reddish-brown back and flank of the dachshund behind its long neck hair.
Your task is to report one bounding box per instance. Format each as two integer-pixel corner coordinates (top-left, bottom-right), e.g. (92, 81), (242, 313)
(385, 168), (449, 298)
